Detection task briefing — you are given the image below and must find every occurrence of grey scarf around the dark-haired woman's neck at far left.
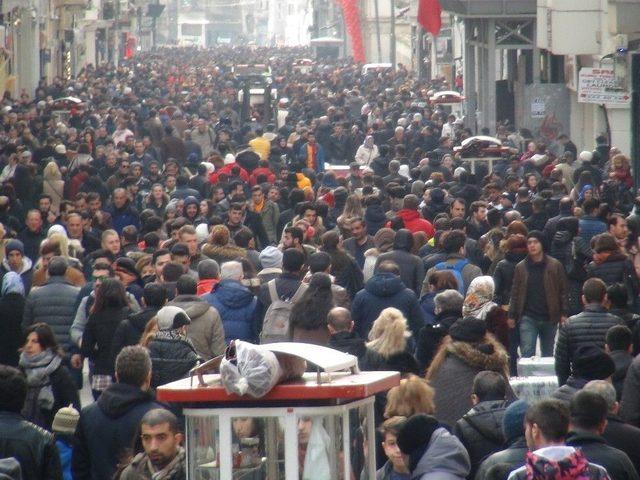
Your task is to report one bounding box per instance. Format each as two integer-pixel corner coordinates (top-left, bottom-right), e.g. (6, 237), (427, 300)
(19, 350), (62, 412)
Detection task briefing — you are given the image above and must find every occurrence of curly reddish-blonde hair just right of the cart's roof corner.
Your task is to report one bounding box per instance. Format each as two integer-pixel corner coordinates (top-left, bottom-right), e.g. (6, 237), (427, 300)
(384, 374), (436, 418)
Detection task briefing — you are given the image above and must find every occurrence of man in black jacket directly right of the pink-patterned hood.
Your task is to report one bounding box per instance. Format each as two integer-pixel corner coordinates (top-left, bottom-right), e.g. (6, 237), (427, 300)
(566, 391), (640, 480)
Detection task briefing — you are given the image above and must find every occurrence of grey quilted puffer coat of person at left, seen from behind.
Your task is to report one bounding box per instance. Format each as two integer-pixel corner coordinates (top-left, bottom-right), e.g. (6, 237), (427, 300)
(22, 277), (80, 352)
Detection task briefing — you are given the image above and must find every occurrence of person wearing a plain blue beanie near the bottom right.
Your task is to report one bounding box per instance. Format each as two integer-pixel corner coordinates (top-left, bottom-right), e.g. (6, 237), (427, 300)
(475, 400), (529, 480)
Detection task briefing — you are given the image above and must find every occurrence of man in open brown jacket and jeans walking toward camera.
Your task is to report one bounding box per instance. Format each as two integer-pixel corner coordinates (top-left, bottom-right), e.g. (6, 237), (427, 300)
(509, 230), (568, 358)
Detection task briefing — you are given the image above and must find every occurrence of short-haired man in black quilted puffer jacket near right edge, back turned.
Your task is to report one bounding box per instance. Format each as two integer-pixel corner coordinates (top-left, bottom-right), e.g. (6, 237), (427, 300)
(555, 278), (622, 385)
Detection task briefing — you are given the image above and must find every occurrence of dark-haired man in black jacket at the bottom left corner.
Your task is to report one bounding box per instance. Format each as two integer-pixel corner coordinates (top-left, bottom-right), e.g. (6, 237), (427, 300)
(0, 365), (62, 480)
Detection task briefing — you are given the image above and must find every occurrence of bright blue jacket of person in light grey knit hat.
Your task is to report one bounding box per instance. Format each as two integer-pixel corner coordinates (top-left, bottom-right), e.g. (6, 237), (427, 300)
(202, 280), (259, 344)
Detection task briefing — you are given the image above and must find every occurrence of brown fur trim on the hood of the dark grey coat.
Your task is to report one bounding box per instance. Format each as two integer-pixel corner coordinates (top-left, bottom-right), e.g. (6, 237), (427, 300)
(427, 334), (509, 379)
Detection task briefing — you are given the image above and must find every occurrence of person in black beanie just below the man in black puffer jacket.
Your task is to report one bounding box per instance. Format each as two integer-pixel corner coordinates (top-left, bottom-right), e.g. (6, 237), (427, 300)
(551, 344), (616, 403)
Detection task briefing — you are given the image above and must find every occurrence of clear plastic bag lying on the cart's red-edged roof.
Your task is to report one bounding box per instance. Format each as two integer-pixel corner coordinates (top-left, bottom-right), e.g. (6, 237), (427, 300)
(220, 340), (282, 398)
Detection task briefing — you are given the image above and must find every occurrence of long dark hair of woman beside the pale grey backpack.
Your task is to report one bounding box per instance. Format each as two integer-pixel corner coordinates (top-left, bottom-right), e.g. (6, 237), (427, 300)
(289, 273), (333, 332)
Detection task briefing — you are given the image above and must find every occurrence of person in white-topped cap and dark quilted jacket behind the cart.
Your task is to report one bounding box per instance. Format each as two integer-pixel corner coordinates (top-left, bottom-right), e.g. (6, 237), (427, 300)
(147, 306), (199, 388)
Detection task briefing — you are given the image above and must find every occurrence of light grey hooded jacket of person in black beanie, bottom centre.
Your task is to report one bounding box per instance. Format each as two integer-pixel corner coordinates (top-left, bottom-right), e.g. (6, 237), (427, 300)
(411, 427), (471, 480)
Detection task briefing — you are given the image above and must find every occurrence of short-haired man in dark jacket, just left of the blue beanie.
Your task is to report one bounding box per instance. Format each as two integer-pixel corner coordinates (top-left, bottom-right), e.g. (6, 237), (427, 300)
(453, 371), (507, 478)
